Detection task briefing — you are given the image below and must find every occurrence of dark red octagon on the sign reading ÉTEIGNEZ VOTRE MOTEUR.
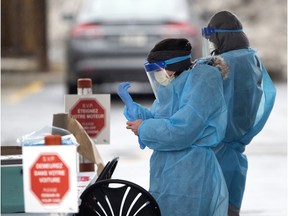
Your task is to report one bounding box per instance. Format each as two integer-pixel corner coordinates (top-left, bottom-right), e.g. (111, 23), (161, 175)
(70, 98), (105, 138)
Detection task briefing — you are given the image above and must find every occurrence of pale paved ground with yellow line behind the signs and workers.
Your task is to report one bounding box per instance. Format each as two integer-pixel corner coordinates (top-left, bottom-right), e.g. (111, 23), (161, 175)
(1, 72), (287, 216)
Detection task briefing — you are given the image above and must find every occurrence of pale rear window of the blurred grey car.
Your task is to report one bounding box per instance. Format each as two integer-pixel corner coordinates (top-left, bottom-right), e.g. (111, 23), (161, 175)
(77, 0), (189, 22)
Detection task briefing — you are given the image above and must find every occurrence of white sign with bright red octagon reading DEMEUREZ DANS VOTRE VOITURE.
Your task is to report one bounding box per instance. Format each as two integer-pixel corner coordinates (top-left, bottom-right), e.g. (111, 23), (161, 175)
(23, 145), (78, 213)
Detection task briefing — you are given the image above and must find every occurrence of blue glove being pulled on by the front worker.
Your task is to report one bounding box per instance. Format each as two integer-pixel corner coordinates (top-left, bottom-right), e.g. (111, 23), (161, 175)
(117, 82), (146, 149)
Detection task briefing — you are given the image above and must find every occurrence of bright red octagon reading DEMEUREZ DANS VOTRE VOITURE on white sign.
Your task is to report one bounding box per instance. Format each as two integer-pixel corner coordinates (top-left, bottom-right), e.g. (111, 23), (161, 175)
(30, 154), (69, 205)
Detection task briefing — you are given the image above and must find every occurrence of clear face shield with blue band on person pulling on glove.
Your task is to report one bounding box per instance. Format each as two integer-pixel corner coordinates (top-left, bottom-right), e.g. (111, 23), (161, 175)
(144, 55), (191, 101)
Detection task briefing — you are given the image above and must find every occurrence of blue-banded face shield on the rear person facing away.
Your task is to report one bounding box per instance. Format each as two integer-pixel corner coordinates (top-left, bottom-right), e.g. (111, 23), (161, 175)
(202, 27), (243, 57)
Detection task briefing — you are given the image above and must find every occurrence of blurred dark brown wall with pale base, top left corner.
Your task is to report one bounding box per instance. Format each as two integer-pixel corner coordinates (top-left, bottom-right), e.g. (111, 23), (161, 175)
(1, 0), (48, 70)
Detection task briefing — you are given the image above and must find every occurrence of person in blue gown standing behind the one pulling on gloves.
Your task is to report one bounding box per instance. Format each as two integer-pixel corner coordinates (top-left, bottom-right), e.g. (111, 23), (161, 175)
(202, 11), (276, 215)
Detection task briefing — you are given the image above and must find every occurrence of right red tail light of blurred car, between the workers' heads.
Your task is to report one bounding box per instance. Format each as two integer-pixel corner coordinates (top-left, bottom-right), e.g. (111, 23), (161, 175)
(164, 22), (197, 36)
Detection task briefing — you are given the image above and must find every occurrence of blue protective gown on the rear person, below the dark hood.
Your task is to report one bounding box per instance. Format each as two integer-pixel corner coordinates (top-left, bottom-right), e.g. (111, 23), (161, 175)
(215, 48), (276, 209)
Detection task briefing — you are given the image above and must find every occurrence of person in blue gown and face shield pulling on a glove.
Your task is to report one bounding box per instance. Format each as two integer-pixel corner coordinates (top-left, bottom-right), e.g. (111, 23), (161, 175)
(118, 38), (228, 216)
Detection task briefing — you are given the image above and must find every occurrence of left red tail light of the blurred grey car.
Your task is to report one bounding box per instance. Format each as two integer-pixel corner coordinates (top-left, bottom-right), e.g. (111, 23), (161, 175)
(70, 23), (103, 38)
